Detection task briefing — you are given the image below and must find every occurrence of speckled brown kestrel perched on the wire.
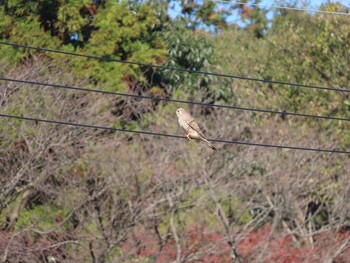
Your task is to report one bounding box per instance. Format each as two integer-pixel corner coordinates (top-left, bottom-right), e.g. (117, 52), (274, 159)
(176, 108), (216, 150)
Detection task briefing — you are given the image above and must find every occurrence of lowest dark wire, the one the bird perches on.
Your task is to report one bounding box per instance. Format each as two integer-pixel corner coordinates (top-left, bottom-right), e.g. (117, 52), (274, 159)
(0, 113), (350, 154)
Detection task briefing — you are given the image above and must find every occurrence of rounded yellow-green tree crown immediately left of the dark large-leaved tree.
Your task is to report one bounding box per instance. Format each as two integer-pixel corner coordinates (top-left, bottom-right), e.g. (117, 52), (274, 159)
(86, 1), (165, 90)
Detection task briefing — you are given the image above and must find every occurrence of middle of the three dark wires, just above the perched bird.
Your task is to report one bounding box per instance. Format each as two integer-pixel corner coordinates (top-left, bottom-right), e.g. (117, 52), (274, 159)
(0, 77), (350, 121)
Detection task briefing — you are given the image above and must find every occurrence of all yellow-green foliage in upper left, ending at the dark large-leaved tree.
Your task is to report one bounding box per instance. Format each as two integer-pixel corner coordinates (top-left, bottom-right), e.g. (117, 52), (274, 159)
(0, 0), (166, 91)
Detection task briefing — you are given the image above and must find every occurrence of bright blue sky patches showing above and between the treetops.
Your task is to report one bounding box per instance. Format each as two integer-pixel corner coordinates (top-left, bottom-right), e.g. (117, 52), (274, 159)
(169, 0), (350, 22)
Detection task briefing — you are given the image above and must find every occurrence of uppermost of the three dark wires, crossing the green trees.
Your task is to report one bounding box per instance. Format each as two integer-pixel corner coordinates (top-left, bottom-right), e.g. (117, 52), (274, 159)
(0, 41), (350, 93)
